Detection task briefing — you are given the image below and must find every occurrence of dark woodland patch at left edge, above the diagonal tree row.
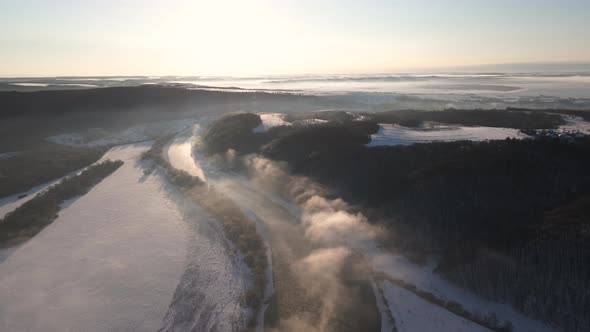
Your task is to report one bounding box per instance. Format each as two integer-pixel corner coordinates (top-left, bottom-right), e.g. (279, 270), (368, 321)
(0, 144), (108, 197)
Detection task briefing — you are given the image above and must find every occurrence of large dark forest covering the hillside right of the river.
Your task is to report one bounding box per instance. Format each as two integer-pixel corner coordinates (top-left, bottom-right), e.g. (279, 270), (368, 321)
(203, 111), (590, 331)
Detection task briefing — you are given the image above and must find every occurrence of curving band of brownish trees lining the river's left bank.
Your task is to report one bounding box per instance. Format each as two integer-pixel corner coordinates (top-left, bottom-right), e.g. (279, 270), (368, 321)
(141, 135), (268, 327)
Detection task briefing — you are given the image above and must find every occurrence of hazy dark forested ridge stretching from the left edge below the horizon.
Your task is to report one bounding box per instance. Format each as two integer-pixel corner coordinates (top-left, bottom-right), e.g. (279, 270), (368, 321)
(0, 84), (338, 151)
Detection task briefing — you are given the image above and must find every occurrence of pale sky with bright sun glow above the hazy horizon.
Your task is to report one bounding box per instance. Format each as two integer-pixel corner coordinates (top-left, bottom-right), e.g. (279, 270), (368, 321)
(0, 0), (590, 77)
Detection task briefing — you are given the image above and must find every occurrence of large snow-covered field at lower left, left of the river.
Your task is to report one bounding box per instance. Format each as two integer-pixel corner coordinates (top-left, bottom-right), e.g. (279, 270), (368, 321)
(0, 144), (187, 331)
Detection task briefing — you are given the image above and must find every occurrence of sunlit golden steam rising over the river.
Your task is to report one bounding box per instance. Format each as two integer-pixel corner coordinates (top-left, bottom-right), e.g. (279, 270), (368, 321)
(242, 156), (382, 331)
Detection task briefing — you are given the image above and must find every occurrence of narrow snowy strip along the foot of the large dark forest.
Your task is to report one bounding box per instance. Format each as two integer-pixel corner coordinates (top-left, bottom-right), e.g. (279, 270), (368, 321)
(371, 253), (553, 332)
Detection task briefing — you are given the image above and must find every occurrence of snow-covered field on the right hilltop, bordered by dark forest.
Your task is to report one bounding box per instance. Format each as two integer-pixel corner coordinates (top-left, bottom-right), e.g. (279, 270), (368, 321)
(367, 124), (528, 146)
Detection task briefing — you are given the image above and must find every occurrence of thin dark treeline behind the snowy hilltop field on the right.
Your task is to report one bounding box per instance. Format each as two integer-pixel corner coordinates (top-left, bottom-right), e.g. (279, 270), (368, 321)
(367, 109), (565, 129)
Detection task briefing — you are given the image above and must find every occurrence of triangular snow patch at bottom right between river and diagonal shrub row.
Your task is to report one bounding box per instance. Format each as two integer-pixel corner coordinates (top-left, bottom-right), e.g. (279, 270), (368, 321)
(383, 282), (491, 332)
